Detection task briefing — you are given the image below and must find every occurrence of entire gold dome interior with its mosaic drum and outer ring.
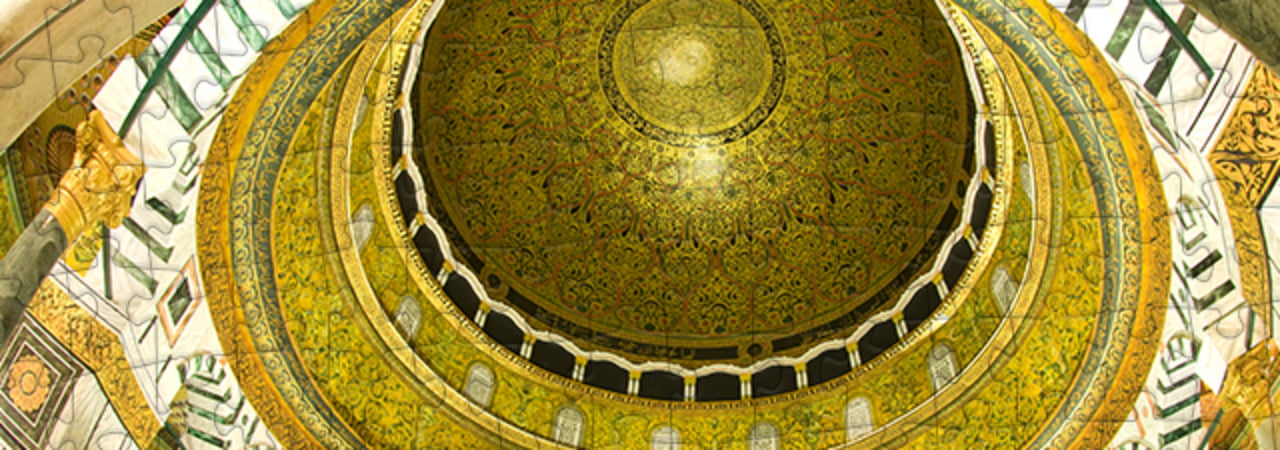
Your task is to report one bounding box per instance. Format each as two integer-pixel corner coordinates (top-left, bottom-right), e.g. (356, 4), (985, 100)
(198, 0), (1169, 447)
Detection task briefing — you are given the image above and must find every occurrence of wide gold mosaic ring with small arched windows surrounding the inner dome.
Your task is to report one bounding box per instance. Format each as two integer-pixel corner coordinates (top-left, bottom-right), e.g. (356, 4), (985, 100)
(198, 0), (1169, 447)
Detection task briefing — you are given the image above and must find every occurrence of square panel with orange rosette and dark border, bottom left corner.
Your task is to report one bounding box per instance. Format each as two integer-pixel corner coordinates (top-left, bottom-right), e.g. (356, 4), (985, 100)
(0, 314), (84, 449)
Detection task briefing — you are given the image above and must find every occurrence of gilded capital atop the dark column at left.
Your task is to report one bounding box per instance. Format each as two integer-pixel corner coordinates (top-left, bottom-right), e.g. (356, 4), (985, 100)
(45, 111), (146, 240)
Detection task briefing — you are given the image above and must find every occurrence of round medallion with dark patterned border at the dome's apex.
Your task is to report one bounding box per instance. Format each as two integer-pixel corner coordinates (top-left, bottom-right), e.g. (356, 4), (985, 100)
(599, 0), (786, 147)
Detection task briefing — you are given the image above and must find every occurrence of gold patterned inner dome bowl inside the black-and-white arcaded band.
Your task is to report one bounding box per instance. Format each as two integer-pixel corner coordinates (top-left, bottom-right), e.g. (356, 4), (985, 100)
(412, 0), (974, 363)
